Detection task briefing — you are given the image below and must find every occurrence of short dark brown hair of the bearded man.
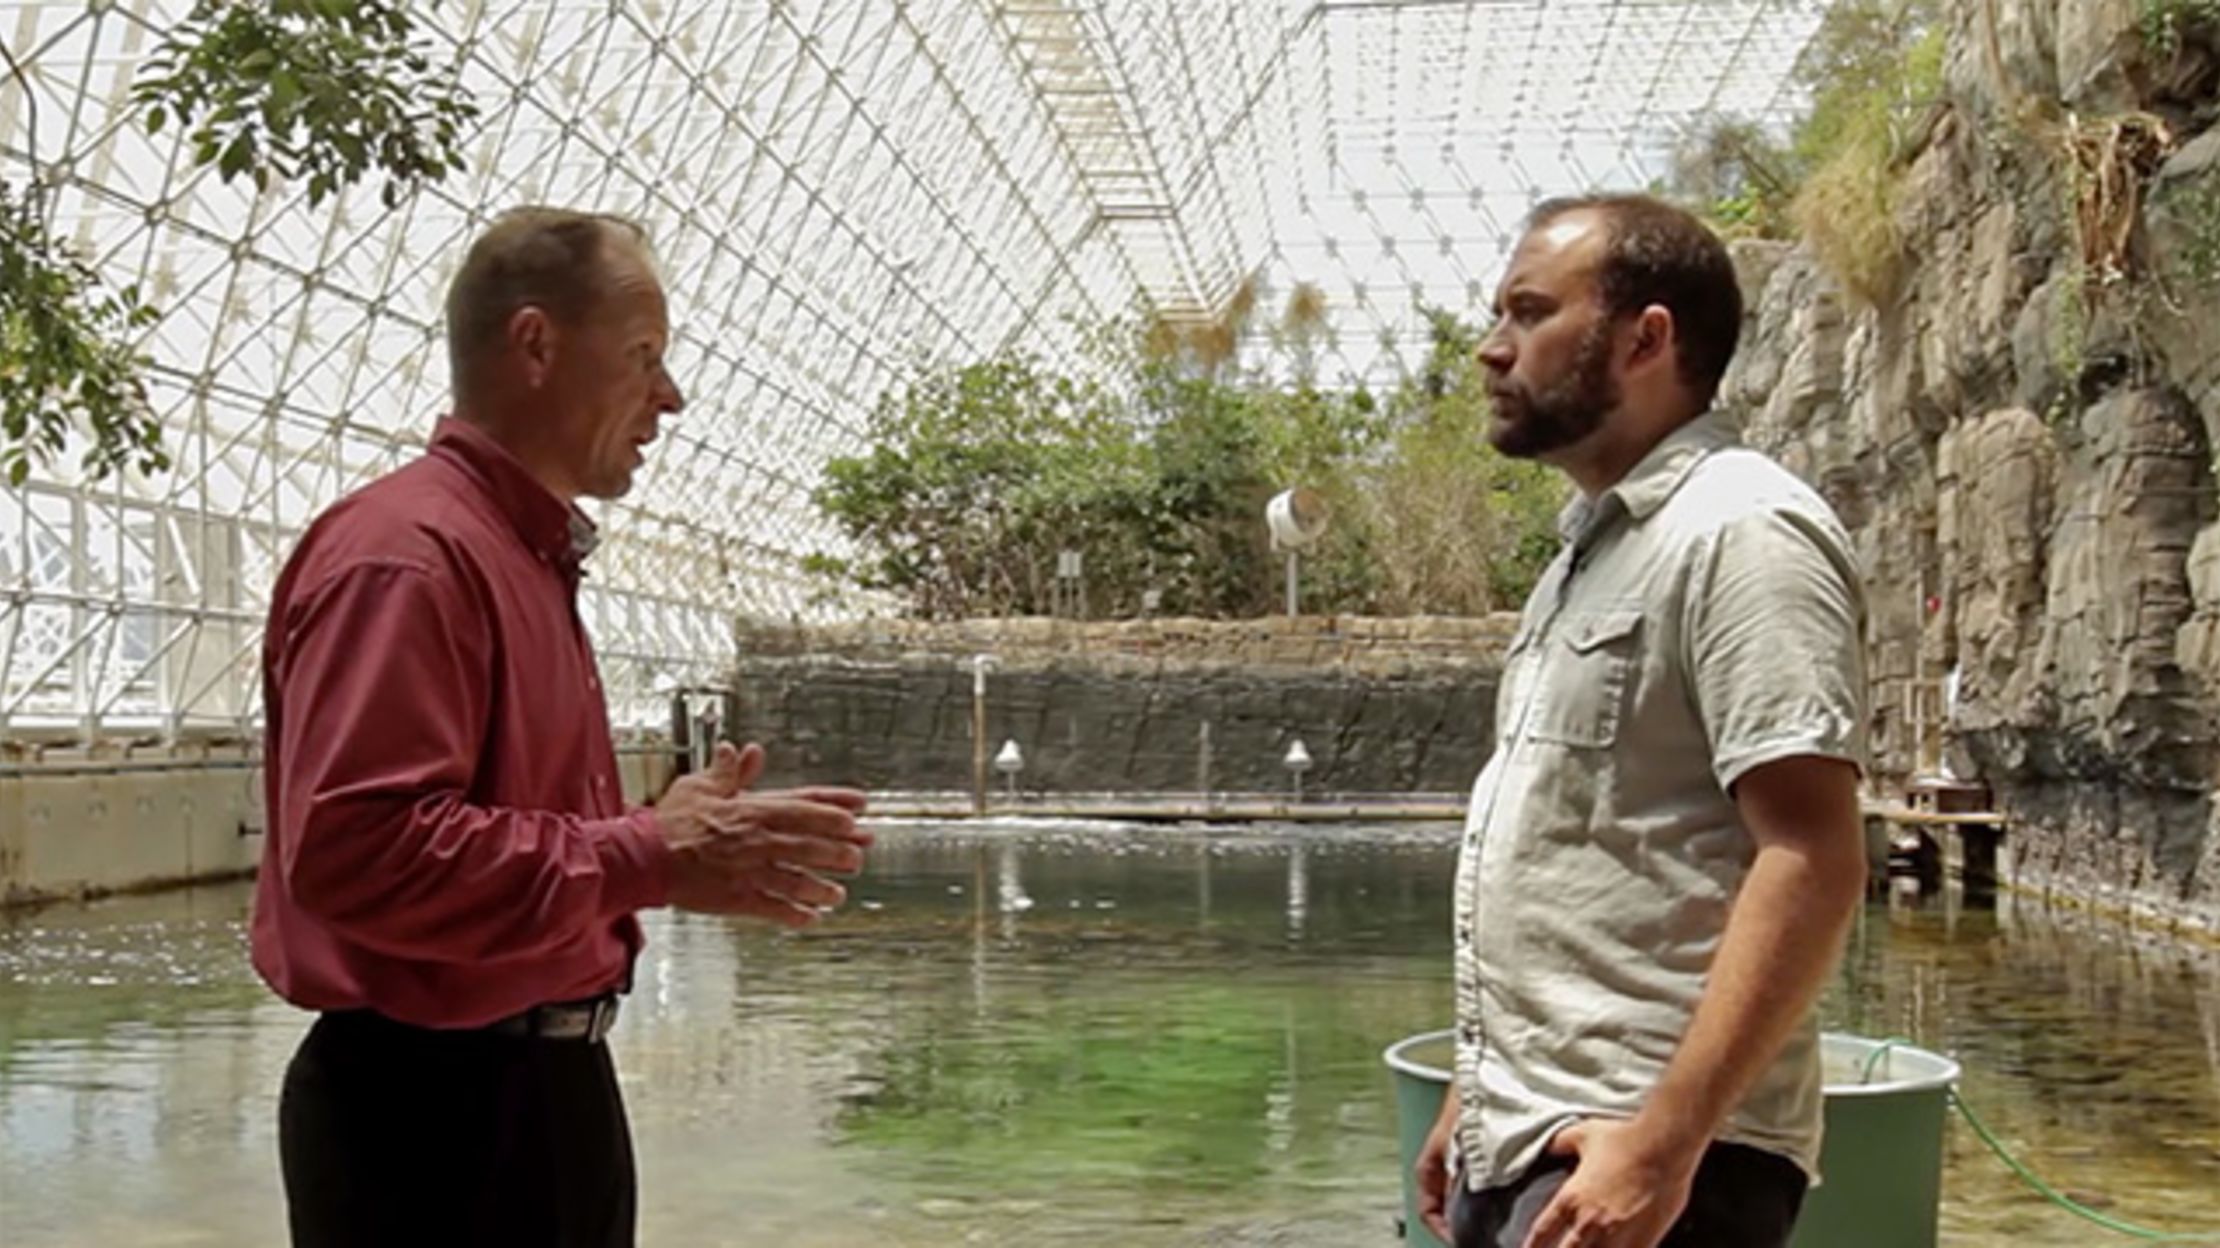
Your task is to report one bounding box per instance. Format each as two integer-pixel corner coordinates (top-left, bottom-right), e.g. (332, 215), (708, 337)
(1527, 195), (1743, 406)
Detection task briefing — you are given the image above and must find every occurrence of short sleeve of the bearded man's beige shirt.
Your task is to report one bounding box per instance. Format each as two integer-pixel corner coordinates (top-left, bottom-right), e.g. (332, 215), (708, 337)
(1683, 509), (1867, 791)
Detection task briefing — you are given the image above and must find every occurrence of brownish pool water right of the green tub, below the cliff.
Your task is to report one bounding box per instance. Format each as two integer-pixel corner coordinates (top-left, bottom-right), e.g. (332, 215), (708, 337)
(1829, 893), (2220, 1246)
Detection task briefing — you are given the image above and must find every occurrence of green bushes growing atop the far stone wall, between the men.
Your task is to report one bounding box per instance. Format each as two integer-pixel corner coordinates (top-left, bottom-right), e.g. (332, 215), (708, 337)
(810, 313), (1561, 620)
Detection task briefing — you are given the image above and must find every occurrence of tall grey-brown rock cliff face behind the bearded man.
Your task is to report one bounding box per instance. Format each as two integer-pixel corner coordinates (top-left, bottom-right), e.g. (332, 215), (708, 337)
(1723, 0), (2220, 930)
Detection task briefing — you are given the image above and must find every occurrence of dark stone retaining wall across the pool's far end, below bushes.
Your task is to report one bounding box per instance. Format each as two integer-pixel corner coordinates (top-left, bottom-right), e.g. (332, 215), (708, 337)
(733, 615), (1512, 793)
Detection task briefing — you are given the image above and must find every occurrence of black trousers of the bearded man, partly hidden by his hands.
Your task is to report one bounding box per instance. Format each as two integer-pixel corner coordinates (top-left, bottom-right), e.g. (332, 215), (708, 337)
(1450, 1144), (1807, 1248)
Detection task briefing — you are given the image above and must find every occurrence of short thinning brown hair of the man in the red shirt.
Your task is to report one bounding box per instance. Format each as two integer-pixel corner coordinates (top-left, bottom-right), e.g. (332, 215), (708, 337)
(446, 207), (648, 393)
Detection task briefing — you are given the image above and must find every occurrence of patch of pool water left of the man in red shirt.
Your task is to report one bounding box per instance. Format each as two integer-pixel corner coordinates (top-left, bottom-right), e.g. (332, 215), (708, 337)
(0, 888), (297, 1246)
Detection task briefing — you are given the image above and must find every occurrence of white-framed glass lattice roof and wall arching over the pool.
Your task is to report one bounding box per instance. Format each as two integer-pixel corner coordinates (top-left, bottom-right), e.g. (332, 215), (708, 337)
(0, 0), (1820, 735)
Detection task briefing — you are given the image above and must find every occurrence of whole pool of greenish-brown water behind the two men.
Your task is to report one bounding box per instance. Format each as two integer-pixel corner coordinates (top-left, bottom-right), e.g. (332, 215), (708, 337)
(0, 824), (2220, 1248)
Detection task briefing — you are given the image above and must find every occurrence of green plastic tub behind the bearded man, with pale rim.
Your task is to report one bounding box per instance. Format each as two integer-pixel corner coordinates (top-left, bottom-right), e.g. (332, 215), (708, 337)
(1385, 1030), (1958, 1248)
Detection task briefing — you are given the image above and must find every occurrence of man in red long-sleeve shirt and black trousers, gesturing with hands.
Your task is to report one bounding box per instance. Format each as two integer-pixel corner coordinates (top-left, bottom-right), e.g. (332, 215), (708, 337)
(253, 209), (870, 1248)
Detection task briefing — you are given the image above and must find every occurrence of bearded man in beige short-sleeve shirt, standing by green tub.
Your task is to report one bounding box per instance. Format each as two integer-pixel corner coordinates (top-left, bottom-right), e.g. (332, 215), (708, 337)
(1419, 195), (1865, 1248)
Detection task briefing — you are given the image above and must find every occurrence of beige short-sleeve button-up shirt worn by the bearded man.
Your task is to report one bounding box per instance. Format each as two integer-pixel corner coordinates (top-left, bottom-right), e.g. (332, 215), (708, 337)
(1452, 417), (1865, 1188)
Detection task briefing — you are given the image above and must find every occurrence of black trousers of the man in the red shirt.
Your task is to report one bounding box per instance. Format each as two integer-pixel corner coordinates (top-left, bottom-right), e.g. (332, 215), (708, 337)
(278, 1013), (637, 1248)
